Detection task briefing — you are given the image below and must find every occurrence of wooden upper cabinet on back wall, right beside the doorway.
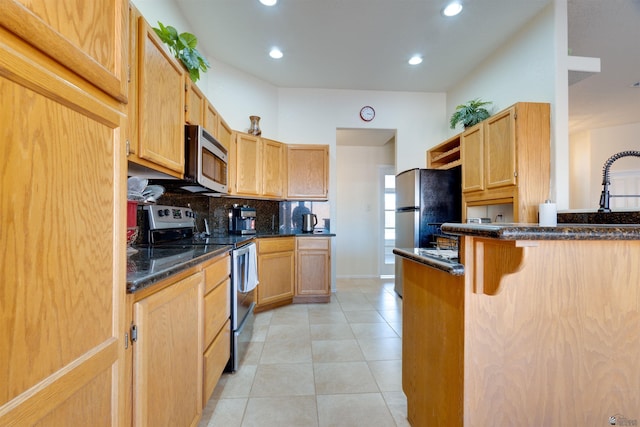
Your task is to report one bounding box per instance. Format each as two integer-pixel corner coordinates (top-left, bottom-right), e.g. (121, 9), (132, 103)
(287, 144), (329, 200)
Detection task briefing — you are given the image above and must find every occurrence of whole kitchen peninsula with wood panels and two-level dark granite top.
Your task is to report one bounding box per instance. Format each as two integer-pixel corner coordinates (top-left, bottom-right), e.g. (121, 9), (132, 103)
(394, 224), (640, 426)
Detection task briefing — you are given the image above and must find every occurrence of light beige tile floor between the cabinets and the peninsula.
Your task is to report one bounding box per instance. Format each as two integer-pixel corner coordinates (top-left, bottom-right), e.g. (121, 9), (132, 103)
(199, 279), (409, 427)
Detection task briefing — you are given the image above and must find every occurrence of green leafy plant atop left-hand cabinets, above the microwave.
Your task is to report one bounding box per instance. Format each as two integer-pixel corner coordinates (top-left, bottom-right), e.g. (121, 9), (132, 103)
(153, 21), (211, 82)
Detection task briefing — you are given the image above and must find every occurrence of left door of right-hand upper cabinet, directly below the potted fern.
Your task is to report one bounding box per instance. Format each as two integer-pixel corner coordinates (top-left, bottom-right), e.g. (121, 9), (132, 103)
(460, 123), (485, 193)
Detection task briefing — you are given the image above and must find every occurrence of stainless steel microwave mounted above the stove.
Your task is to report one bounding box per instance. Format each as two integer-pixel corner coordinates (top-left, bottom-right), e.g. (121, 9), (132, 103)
(184, 125), (229, 193)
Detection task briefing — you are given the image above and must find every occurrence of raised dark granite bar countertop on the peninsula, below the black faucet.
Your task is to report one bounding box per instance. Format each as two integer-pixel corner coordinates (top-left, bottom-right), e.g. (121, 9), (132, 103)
(442, 223), (640, 240)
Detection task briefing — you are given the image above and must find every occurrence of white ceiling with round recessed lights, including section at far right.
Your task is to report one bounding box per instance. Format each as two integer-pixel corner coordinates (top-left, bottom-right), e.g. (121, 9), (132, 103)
(177, 0), (640, 142)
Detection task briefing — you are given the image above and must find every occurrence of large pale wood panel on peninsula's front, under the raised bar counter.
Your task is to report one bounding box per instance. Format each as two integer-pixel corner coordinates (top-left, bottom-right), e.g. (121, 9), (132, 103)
(465, 239), (640, 426)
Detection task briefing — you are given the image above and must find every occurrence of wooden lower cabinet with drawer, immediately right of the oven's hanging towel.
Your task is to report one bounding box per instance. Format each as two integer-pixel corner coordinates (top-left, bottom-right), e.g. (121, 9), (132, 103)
(255, 237), (295, 312)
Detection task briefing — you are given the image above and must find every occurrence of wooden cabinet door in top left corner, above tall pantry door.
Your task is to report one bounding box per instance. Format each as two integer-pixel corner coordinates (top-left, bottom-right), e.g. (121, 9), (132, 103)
(0, 0), (128, 102)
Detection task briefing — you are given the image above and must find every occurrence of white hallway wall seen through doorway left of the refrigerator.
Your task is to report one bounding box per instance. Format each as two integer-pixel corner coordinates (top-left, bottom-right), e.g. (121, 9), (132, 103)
(332, 144), (394, 278)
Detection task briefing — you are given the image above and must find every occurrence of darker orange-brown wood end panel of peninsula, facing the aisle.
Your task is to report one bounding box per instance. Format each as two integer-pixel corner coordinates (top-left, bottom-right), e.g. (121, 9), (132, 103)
(398, 258), (465, 427)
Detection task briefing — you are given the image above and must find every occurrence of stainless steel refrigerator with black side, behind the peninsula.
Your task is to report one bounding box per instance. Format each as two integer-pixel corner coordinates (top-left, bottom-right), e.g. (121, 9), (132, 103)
(395, 166), (462, 296)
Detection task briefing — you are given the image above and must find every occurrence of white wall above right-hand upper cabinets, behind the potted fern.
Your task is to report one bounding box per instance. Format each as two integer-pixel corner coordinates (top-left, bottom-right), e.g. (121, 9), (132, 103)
(447, 2), (568, 206)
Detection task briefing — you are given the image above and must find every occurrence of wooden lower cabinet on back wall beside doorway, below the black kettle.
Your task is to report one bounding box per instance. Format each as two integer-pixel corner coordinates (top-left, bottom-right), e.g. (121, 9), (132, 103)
(293, 237), (331, 303)
